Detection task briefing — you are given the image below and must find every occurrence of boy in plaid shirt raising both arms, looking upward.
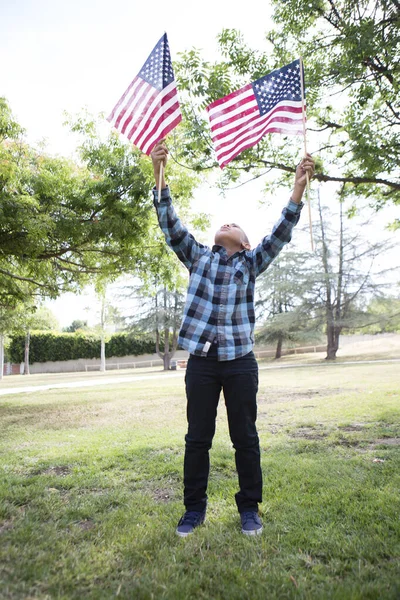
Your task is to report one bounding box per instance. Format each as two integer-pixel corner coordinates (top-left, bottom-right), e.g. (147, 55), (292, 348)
(151, 140), (314, 537)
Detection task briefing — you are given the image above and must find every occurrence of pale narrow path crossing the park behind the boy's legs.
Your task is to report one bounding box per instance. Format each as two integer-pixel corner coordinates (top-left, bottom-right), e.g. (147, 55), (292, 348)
(0, 358), (400, 396)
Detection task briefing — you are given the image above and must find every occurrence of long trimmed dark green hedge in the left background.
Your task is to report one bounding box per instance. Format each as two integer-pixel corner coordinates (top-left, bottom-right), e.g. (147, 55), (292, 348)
(7, 332), (155, 363)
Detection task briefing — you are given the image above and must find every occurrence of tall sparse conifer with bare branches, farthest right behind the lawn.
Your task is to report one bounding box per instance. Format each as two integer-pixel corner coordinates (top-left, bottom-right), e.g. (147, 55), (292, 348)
(303, 189), (392, 360)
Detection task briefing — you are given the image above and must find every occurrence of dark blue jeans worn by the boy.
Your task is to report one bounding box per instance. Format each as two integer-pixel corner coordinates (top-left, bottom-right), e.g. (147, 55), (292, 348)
(184, 346), (262, 513)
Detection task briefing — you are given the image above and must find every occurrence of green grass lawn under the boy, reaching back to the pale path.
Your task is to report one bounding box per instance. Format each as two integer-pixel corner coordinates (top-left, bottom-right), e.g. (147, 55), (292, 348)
(0, 363), (400, 600)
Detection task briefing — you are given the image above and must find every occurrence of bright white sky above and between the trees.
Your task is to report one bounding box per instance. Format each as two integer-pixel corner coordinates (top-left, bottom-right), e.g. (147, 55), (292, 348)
(0, 0), (398, 326)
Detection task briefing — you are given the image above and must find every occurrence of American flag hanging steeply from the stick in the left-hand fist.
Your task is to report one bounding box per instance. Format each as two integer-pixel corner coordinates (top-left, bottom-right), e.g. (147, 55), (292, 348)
(107, 33), (182, 154)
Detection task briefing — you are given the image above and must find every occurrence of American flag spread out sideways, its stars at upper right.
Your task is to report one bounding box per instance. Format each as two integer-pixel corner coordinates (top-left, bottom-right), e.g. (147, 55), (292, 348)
(207, 59), (303, 169)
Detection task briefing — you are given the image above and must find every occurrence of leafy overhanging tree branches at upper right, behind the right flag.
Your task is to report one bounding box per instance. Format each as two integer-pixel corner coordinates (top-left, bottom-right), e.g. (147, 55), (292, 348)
(176, 0), (400, 220)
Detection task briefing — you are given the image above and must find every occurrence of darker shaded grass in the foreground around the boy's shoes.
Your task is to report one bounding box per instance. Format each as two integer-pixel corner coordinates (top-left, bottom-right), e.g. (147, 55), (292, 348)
(0, 438), (400, 600)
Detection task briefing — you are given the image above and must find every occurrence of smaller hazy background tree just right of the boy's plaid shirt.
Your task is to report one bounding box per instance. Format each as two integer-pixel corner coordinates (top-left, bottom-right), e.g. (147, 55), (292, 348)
(256, 250), (320, 359)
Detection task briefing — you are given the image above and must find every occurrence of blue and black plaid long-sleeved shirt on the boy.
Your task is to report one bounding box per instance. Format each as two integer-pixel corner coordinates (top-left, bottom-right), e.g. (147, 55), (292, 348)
(154, 188), (303, 361)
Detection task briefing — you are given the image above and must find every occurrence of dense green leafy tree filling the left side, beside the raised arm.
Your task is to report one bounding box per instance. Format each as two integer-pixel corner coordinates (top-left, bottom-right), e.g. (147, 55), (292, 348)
(0, 99), (197, 306)
